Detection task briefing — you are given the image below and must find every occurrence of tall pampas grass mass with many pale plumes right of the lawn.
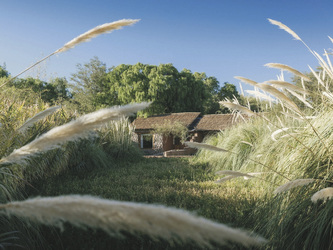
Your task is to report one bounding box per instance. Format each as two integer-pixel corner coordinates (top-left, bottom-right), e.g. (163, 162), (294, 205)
(189, 19), (333, 249)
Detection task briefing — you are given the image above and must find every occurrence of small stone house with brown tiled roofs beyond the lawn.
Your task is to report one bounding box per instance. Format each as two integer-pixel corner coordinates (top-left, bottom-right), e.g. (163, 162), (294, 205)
(133, 112), (241, 154)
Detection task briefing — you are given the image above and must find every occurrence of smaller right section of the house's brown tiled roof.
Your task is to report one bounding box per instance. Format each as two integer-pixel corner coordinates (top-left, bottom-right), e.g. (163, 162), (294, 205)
(195, 114), (239, 131)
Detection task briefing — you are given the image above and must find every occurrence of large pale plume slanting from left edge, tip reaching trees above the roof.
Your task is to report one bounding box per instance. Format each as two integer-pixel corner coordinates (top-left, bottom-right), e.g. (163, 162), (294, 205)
(0, 102), (150, 163)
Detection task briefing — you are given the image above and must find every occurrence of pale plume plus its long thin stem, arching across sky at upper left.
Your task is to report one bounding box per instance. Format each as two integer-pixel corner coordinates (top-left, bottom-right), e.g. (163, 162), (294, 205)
(0, 19), (140, 88)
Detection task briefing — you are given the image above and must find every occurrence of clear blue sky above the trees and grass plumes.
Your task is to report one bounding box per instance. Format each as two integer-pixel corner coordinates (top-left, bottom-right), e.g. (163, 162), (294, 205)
(0, 0), (333, 90)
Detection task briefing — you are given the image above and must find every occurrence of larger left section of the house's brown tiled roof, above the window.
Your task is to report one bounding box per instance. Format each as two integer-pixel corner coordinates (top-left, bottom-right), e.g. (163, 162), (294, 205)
(133, 112), (200, 130)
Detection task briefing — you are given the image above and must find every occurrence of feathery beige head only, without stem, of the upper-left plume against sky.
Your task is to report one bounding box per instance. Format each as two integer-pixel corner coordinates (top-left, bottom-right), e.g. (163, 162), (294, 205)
(54, 19), (140, 53)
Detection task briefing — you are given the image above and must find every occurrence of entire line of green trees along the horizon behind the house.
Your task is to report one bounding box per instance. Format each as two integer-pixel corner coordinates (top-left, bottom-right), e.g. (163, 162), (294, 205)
(0, 57), (240, 116)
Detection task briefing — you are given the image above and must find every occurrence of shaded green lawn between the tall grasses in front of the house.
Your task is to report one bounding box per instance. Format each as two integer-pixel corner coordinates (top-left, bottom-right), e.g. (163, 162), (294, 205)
(24, 158), (264, 249)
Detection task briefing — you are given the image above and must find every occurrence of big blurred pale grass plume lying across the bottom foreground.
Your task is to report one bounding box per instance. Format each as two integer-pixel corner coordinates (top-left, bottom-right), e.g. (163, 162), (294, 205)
(0, 195), (265, 247)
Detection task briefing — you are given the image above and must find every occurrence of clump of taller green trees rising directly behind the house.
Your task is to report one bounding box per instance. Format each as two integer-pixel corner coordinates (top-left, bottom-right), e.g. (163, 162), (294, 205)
(71, 57), (232, 115)
